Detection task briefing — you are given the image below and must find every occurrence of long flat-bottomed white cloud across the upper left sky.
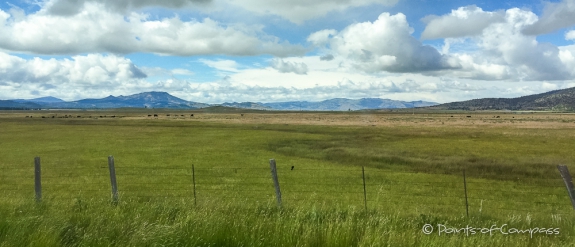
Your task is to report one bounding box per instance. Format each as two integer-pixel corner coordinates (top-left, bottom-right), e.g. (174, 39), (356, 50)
(0, 2), (305, 57)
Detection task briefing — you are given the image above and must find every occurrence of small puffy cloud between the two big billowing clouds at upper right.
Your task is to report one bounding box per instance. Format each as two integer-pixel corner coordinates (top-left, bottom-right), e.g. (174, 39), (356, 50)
(421, 5), (505, 39)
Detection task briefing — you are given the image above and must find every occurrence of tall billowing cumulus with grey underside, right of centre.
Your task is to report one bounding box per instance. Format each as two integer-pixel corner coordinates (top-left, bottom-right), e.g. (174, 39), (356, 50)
(322, 13), (459, 72)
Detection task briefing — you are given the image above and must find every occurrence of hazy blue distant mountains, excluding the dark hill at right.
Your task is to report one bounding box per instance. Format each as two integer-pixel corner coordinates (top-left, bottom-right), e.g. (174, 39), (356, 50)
(0, 92), (437, 111)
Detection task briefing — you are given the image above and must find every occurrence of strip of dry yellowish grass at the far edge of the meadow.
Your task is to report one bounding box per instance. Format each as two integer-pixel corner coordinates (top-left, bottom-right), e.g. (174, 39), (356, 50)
(4, 110), (575, 129)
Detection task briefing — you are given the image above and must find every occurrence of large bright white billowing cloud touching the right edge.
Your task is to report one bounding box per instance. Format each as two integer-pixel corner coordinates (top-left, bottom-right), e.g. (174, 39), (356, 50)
(430, 8), (575, 81)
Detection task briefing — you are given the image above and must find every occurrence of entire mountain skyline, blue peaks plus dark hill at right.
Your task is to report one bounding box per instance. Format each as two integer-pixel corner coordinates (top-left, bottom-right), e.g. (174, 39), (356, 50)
(6, 87), (575, 111)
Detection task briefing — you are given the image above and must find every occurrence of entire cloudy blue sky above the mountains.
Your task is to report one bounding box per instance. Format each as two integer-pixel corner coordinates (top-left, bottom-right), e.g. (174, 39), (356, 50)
(0, 0), (575, 103)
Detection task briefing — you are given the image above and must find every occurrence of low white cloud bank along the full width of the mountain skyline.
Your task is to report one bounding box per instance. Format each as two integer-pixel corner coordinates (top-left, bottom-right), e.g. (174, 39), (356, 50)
(4, 52), (575, 103)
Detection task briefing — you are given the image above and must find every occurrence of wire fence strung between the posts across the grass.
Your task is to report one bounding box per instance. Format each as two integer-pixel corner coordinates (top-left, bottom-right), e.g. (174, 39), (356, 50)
(0, 156), (573, 214)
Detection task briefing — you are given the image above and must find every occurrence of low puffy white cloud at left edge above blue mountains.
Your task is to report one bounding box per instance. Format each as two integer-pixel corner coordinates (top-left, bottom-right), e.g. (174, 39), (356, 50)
(0, 52), (147, 98)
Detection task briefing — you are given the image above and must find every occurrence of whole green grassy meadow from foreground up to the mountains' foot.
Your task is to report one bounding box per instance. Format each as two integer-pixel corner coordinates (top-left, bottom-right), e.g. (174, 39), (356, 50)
(0, 110), (575, 247)
